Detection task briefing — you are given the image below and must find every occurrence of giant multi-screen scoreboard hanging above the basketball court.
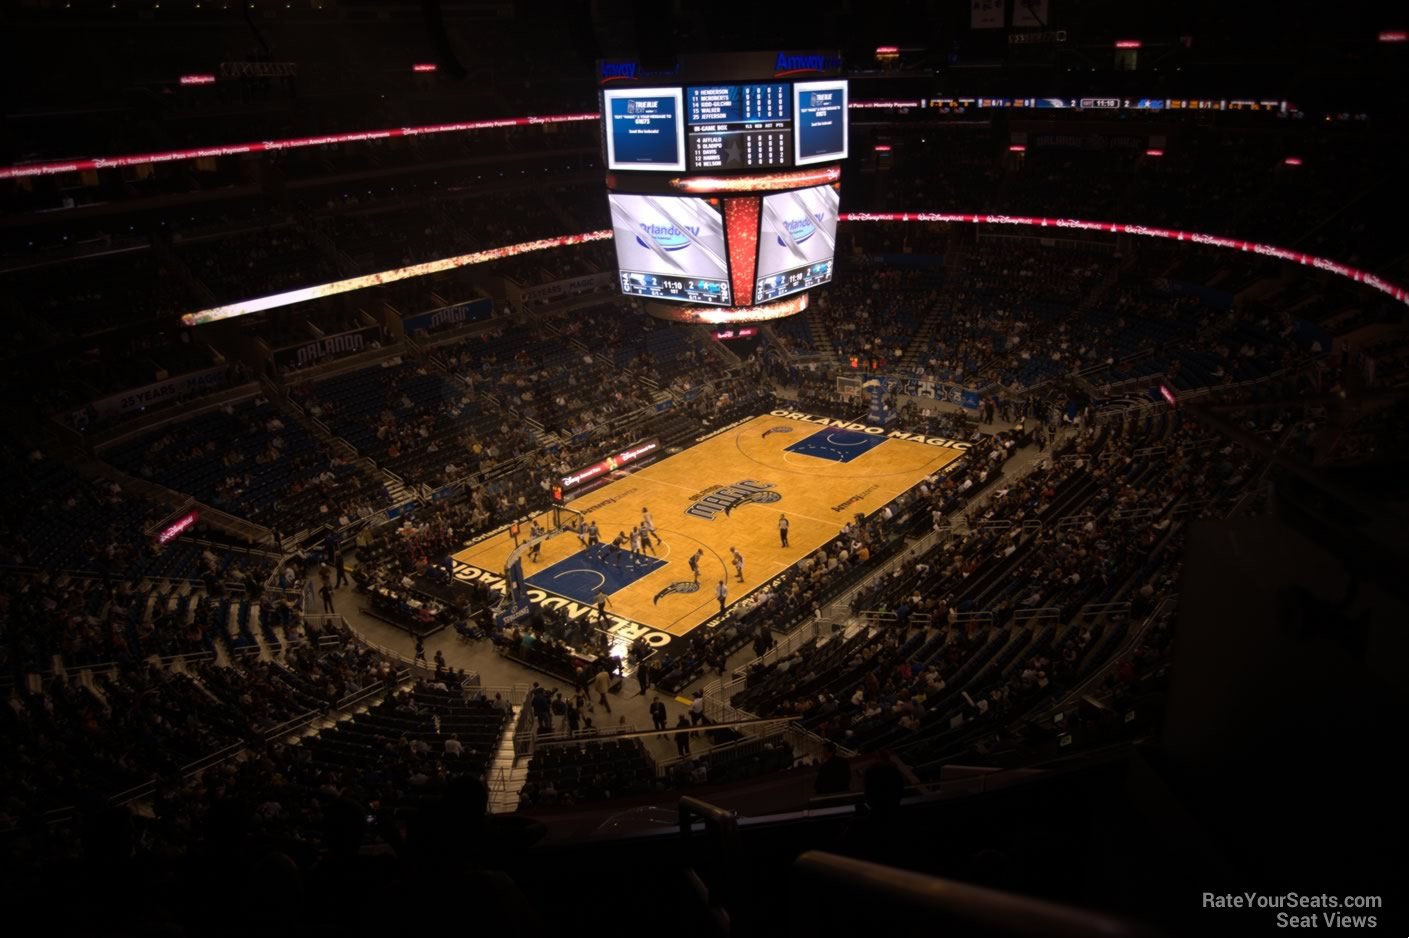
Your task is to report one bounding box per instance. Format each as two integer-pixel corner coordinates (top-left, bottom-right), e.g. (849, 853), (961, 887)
(599, 52), (850, 323)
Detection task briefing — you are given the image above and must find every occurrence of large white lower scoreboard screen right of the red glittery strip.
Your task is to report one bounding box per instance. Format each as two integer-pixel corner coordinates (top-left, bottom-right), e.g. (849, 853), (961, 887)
(754, 186), (841, 303)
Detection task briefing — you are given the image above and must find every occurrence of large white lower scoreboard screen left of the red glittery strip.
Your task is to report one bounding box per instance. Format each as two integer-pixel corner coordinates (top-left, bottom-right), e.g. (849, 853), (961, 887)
(607, 193), (733, 306)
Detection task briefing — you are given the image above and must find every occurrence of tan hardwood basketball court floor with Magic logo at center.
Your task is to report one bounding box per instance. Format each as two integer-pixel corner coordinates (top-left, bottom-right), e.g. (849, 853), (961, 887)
(455, 415), (962, 638)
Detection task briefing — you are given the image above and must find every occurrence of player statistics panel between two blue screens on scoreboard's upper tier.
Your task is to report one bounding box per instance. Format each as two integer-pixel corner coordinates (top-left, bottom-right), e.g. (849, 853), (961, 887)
(685, 82), (792, 170)
